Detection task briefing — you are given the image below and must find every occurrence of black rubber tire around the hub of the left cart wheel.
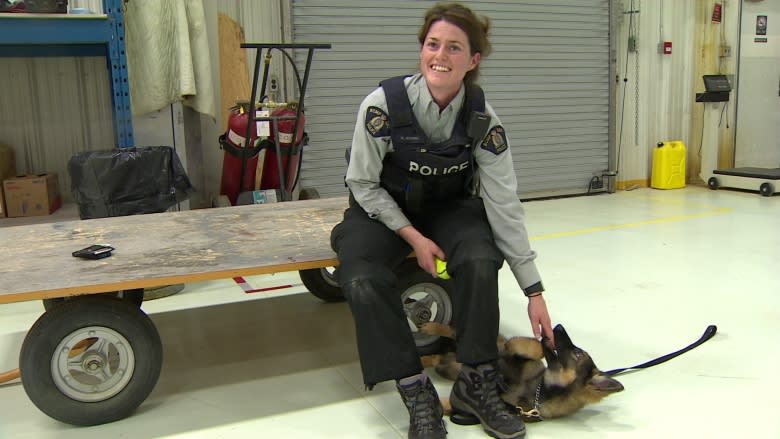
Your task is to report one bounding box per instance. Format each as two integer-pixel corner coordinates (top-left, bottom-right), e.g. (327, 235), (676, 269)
(19, 296), (162, 426)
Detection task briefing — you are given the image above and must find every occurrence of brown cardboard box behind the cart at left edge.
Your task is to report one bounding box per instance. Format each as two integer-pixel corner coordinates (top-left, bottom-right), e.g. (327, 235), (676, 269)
(3, 172), (62, 218)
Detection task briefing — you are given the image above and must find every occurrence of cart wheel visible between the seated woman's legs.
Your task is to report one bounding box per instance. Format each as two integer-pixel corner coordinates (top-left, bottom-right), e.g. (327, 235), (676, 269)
(398, 258), (453, 355)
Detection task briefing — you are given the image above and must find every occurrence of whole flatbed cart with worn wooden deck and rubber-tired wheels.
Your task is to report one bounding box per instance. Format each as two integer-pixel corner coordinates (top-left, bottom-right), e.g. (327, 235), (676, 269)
(0, 198), (452, 425)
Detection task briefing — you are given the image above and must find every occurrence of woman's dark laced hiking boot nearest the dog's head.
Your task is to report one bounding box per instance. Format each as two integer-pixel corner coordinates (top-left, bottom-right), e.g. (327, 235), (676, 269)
(450, 363), (525, 439)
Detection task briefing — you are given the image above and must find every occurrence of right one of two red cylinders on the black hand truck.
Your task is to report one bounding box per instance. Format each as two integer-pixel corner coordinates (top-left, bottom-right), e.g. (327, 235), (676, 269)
(260, 105), (306, 193)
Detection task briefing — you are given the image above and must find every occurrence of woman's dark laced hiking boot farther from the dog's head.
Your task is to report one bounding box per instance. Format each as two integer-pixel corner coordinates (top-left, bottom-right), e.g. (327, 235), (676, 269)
(396, 374), (447, 439)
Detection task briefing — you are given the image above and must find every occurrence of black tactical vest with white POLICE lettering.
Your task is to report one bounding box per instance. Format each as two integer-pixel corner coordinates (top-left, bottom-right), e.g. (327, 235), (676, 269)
(380, 76), (485, 214)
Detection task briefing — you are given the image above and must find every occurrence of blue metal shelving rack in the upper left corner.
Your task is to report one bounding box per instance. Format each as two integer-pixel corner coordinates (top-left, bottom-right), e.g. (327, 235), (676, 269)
(0, 0), (134, 148)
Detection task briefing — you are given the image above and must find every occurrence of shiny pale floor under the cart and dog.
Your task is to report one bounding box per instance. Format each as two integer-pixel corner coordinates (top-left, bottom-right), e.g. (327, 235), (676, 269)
(0, 187), (780, 439)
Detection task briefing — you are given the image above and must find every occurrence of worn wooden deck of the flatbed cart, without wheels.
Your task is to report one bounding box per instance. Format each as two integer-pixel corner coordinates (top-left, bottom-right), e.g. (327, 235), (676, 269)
(0, 198), (347, 304)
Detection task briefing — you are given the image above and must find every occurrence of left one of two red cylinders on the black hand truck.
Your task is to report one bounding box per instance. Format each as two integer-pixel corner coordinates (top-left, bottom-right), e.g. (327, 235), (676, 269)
(219, 103), (262, 206)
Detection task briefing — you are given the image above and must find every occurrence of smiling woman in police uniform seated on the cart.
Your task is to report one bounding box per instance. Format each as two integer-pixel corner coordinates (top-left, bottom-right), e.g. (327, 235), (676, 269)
(331, 4), (553, 438)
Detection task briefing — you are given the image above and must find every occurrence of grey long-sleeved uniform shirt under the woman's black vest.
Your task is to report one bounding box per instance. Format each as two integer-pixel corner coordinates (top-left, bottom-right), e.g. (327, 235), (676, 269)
(346, 73), (541, 290)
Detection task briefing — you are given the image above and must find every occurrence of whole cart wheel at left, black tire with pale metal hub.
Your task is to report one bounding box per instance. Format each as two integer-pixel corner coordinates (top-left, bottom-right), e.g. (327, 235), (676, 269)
(19, 295), (162, 425)
